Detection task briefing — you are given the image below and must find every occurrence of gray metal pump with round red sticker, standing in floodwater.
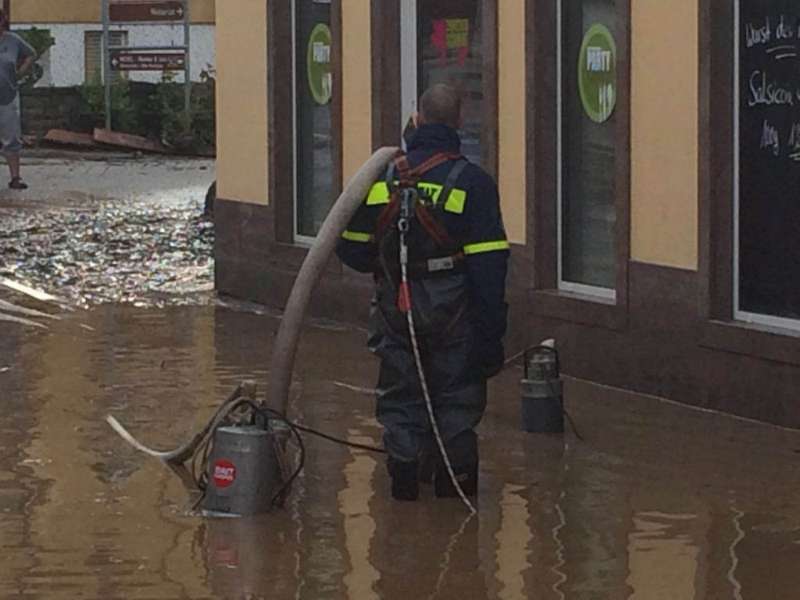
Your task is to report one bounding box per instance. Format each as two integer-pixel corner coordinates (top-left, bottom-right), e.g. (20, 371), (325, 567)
(203, 426), (282, 516)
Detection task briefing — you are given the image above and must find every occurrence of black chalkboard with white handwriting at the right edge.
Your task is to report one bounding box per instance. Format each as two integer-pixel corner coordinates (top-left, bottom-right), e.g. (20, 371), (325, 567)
(736, 0), (800, 319)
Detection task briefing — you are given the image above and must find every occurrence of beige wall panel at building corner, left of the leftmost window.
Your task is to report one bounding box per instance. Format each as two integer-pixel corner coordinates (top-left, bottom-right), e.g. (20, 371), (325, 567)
(216, 0), (268, 204)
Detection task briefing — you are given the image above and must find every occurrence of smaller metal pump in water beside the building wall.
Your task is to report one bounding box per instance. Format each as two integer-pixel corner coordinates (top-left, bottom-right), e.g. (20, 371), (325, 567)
(522, 346), (564, 433)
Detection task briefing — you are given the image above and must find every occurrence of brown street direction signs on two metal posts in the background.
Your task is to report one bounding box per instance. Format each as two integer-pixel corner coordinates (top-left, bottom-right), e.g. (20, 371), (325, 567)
(101, 0), (192, 129)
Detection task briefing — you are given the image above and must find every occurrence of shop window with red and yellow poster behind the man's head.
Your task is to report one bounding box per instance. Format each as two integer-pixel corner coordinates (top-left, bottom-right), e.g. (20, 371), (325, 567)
(417, 0), (482, 163)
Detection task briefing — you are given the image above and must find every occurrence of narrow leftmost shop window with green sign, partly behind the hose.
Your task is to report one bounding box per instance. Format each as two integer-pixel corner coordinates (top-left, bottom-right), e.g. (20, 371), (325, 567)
(294, 0), (335, 237)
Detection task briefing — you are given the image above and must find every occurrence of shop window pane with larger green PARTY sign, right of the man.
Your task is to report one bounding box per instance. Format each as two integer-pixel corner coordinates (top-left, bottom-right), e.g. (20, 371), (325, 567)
(558, 0), (621, 298)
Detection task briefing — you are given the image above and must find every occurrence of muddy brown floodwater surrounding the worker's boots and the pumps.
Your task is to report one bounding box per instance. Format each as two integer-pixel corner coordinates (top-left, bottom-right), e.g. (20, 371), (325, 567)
(0, 298), (800, 600)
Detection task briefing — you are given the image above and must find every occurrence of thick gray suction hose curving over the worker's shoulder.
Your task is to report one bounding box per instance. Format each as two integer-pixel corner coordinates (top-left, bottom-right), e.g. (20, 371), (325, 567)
(268, 147), (400, 414)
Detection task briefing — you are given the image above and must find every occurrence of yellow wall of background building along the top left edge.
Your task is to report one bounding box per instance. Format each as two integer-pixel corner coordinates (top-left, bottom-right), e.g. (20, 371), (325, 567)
(16, 0), (216, 23)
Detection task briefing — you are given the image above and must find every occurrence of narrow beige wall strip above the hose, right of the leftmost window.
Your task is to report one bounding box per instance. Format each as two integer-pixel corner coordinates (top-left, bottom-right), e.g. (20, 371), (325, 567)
(342, 0), (372, 183)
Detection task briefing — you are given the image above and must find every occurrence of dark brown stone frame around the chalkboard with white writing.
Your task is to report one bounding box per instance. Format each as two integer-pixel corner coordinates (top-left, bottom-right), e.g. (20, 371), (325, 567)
(697, 0), (800, 365)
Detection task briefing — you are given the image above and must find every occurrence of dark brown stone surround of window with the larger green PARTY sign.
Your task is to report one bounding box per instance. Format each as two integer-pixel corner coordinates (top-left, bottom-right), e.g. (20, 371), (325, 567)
(526, 0), (631, 329)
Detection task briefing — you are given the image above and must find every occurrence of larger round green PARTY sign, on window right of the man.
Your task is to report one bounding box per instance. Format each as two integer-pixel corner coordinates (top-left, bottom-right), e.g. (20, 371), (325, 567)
(578, 23), (617, 123)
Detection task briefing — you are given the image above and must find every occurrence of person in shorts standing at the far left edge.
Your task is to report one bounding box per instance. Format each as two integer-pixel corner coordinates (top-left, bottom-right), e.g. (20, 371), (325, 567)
(0, 10), (36, 190)
